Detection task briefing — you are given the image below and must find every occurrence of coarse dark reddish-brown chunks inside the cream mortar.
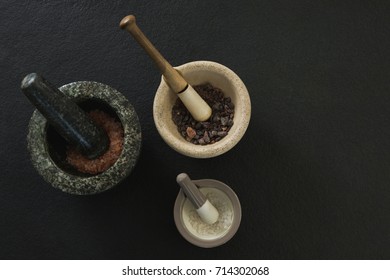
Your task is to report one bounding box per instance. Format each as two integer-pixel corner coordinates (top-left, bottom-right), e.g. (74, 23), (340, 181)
(172, 83), (234, 145)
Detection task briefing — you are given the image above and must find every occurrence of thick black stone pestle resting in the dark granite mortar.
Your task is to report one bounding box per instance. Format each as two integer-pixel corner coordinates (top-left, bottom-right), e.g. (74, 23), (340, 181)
(21, 73), (109, 159)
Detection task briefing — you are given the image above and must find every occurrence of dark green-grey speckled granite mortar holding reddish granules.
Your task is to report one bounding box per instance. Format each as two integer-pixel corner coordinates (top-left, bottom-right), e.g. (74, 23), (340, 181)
(27, 81), (141, 195)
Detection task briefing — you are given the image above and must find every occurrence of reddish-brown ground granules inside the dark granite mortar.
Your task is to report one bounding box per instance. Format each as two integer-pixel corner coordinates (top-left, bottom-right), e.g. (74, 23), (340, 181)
(66, 110), (124, 175)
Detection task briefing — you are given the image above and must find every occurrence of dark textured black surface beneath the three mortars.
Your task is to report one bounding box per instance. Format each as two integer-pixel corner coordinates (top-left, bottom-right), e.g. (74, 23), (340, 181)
(0, 0), (390, 259)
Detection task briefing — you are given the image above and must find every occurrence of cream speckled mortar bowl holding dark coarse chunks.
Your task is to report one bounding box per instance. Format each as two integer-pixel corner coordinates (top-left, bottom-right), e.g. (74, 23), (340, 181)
(153, 61), (251, 158)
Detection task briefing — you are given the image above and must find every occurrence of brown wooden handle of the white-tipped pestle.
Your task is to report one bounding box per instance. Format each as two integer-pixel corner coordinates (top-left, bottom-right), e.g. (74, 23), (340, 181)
(119, 15), (188, 93)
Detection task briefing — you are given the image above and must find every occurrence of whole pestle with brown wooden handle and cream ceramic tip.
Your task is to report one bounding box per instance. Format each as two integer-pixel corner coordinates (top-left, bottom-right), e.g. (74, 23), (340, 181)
(119, 15), (212, 121)
